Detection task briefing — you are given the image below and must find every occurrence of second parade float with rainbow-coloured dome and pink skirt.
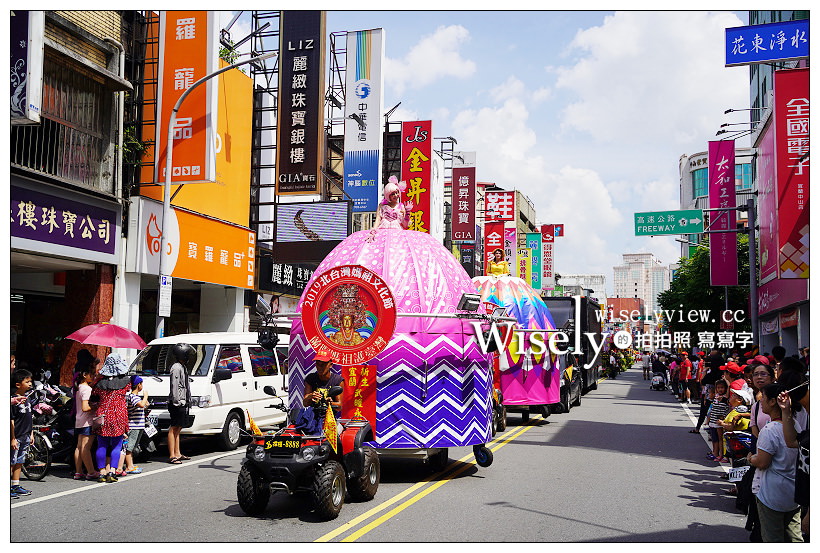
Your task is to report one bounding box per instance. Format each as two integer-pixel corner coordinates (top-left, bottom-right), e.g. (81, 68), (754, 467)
(472, 276), (572, 422)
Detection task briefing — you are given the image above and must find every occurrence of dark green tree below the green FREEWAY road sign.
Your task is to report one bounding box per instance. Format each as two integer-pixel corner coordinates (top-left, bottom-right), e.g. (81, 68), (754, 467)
(658, 233), (752, 336)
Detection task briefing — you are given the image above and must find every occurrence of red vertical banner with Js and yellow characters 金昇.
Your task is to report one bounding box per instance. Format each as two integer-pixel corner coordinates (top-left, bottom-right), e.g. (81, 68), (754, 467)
(401, 121), (433, 233)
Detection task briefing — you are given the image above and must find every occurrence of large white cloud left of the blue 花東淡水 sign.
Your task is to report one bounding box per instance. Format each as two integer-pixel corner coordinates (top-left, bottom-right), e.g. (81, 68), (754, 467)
(556, 12), (748, 147)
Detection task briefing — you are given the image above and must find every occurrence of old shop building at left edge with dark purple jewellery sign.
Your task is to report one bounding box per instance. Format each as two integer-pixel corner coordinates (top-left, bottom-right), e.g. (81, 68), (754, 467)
(9, 10), (132, 384)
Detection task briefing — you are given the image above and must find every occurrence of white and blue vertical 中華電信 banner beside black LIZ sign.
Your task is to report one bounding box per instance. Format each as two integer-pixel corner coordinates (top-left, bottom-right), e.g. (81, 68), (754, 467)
(344, 29), (384, 212)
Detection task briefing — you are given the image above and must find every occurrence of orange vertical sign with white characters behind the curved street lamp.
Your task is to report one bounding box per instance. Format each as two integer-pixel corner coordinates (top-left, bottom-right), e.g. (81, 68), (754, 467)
(154, 11), (219, 184)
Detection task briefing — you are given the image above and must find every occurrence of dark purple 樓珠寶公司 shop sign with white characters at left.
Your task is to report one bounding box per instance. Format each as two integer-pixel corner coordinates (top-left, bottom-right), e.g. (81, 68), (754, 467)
(9, 179), (120, 264)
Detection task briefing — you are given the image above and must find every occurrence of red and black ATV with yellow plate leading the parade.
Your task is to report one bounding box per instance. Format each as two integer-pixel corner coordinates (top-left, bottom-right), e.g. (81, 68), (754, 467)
(236, 386), (380, 520)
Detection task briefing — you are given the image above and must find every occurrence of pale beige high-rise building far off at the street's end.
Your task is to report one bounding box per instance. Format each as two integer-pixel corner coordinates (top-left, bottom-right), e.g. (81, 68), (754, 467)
(612, 253), (671, 313)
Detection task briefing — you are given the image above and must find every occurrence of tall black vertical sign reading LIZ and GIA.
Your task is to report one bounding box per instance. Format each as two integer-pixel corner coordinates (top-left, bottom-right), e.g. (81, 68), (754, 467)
(276, 10), (325, 194)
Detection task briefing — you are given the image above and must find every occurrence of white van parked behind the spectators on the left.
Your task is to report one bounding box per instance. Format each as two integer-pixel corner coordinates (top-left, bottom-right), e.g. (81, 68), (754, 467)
(129, 323), (290, 450)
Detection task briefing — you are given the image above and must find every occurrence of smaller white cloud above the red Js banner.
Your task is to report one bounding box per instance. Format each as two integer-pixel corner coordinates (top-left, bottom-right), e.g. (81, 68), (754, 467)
(384, 25), (476, 96)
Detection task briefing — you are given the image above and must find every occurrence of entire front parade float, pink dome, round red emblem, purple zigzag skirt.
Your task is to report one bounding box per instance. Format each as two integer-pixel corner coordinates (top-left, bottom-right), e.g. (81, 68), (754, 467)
(282, 228), (500, 468)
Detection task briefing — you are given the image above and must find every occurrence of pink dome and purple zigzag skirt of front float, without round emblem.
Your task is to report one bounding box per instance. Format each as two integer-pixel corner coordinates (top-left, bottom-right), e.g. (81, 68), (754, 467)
(288, 229), (492, 448)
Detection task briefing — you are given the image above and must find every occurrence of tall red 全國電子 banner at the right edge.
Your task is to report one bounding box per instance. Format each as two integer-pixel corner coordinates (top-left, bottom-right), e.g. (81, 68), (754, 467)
(774, 69), (809, 278)
